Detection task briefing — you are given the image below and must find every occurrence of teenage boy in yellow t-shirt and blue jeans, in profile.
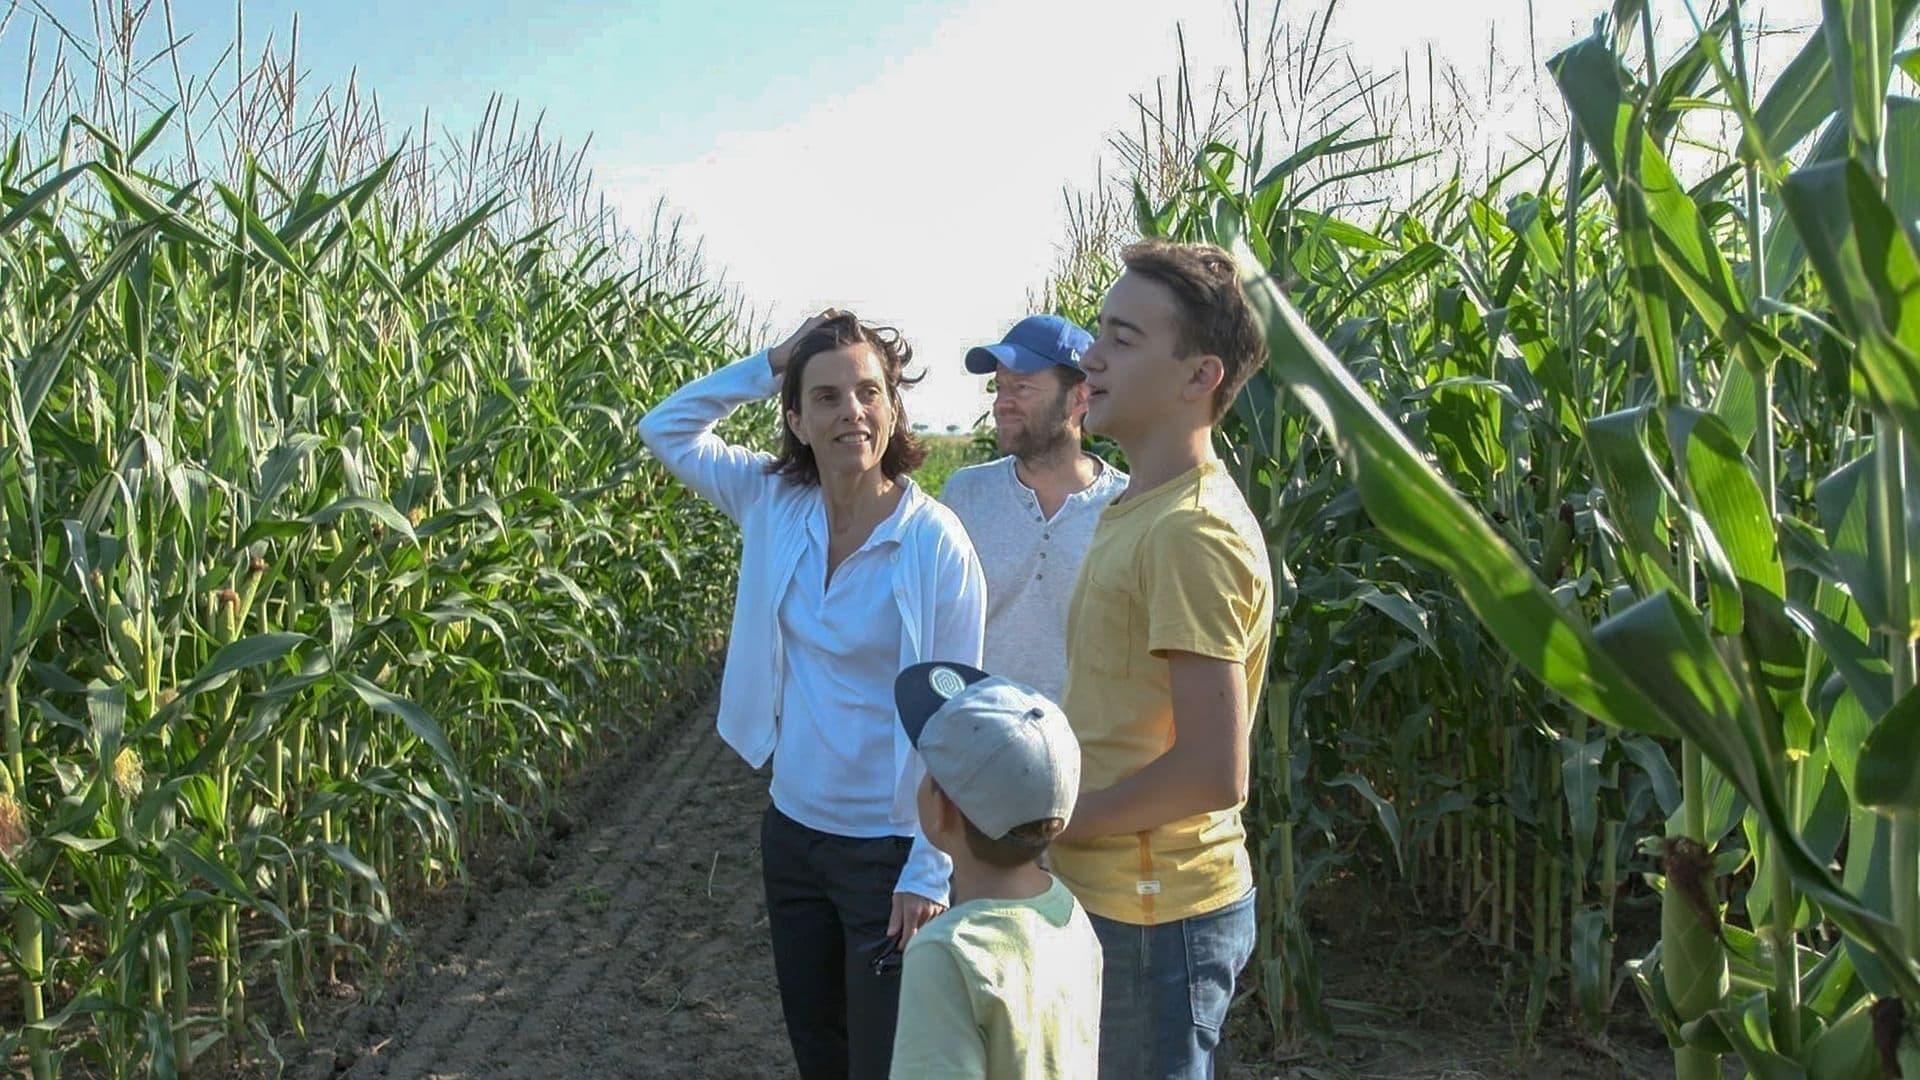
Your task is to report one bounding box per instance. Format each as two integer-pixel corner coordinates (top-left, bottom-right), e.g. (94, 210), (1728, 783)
(1050, 242), (1273, 1078)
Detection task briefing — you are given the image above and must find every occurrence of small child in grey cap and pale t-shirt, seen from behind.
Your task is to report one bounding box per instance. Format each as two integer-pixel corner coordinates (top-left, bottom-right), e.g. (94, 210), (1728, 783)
(876, 663), (1100, 1080)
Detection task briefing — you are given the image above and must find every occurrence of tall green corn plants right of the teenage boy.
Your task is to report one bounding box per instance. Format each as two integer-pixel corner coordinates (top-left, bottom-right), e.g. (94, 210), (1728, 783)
(1048, 0), (1920, 1078)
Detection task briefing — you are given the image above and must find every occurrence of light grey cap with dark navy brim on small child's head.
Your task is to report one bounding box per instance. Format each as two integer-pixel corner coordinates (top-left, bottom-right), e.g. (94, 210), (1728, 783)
(893, 661), (1079, 840)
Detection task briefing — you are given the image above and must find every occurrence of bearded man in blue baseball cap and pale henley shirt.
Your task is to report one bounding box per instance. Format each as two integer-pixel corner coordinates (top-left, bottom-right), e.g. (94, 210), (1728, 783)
(941, 315), (1127, 701)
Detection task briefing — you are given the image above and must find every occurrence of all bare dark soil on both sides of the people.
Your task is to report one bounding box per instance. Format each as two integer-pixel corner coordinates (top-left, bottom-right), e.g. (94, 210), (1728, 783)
(263, 691), (1672, 1080)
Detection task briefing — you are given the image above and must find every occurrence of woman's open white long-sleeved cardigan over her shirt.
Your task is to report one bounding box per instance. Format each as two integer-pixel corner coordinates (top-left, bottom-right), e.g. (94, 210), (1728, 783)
(639, 352), (987, 903)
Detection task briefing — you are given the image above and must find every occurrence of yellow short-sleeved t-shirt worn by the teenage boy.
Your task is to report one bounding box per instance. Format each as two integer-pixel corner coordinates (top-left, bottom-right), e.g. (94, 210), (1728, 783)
(1050, 459), (1273, 926)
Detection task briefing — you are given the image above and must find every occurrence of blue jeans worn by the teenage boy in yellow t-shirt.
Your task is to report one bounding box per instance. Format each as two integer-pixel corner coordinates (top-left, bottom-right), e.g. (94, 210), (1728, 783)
(1089, 892), (1254, 1080)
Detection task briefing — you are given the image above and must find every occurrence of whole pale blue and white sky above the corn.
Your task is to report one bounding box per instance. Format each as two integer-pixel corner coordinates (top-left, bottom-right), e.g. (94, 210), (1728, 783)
(0, 0), (1818, 427)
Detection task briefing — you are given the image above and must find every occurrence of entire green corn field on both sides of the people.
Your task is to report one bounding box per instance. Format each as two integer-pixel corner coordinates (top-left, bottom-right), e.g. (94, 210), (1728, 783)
(11, 0), (1920, 1080)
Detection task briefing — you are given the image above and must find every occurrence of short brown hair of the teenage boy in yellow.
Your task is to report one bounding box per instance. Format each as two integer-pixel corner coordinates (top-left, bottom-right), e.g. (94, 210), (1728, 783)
(1119, 240), (1267, 423)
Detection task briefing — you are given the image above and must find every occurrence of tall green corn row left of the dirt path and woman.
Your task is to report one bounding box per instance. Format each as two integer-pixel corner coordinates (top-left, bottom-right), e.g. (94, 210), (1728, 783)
(0, 67), (741, 1078)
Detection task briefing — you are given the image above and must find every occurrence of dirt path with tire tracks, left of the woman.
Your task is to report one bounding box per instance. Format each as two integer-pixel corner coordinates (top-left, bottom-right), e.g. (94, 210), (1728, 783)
(288, 701), (791, 1080)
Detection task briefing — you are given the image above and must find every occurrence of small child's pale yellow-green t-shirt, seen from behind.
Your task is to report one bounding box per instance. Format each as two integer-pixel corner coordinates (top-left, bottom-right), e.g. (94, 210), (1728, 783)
(893, 880), (1100, 1080)
